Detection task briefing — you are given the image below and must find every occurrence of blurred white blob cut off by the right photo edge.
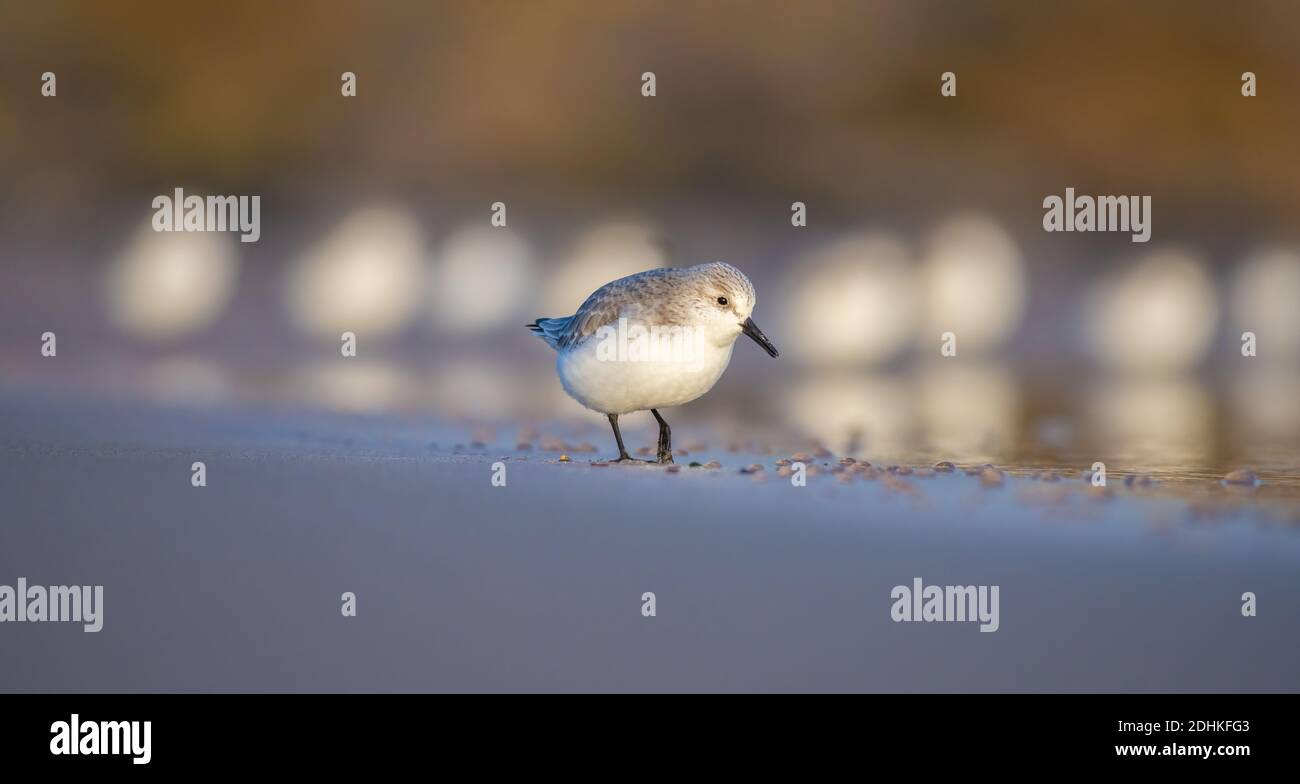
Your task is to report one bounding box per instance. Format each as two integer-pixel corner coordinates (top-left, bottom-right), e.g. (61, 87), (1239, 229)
(1231, 248), (1300, 365)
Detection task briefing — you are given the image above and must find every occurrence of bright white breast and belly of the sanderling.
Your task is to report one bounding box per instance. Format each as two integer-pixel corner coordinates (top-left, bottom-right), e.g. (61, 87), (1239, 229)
(556, 339), (735, 413)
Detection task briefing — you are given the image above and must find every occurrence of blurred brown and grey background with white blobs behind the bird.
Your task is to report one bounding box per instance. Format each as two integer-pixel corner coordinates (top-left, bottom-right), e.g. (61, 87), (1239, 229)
(0, 1), (1300, 477)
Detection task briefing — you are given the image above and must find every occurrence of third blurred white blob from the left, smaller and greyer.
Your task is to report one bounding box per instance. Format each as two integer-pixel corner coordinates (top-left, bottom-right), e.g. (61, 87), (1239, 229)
(429, 226), (533, 334)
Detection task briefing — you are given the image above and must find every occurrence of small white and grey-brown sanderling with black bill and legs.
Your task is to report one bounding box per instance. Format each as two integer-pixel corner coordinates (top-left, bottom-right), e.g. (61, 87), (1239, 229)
(528, 261), (776, 463)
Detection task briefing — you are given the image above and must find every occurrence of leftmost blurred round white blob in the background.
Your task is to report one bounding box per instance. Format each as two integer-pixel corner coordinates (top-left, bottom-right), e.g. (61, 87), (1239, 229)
(104, 226), (238, 341)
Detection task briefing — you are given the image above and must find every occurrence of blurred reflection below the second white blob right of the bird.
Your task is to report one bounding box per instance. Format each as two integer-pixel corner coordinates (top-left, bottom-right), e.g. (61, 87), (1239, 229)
(918, 360), (1019, 460)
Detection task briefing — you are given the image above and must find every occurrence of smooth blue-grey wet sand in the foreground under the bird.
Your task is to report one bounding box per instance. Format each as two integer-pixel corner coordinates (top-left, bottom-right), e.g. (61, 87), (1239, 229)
(0, 394), (1300, 692)
